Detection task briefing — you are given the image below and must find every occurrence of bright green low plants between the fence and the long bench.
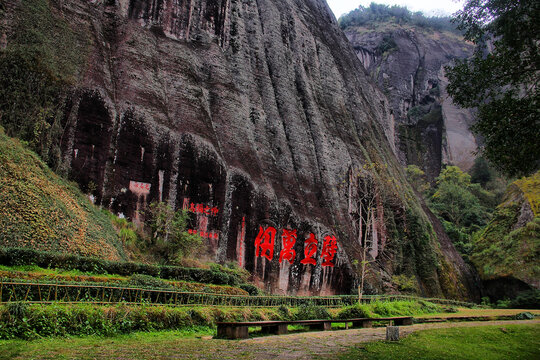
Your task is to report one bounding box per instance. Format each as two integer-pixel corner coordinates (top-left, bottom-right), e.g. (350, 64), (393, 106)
(0, 301), (443, 339)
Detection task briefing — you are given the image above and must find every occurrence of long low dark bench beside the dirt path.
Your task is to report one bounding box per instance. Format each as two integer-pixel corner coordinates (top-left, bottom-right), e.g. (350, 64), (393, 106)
(216, 316), (413, 339)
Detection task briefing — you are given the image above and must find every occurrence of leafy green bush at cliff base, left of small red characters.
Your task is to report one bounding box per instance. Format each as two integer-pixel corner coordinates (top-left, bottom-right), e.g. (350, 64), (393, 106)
(148, 202), (202, 263)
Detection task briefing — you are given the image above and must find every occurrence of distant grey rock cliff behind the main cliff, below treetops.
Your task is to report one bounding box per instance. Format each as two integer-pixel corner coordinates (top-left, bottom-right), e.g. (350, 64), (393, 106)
(345, 23), (477, 179)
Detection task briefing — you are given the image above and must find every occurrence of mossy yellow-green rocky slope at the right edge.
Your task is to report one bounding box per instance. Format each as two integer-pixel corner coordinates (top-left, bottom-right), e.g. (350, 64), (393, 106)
(471, 172), (540, 283)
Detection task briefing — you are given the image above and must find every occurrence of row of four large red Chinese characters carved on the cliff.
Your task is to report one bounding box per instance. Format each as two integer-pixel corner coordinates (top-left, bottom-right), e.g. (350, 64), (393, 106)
(255, 226), (338, 267)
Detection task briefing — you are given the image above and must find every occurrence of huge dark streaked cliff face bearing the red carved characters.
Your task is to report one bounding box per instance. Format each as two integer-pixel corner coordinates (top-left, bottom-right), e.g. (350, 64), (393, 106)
(2, 0), (474, 297)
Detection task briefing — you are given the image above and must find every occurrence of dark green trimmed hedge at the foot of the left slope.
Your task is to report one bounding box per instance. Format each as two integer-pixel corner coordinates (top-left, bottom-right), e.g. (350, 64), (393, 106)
(0, 247), (240, 285)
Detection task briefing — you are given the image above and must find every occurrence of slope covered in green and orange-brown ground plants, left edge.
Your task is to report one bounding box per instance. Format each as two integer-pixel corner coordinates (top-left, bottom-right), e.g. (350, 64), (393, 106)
(0, 128), (125, 260)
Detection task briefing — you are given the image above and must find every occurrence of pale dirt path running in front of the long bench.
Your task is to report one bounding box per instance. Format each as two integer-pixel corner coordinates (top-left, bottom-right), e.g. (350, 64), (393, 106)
(232, 320), (540, 360)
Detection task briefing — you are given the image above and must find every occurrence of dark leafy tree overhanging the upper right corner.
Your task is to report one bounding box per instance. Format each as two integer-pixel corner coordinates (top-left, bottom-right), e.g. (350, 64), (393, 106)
(446, 0), (540, 176)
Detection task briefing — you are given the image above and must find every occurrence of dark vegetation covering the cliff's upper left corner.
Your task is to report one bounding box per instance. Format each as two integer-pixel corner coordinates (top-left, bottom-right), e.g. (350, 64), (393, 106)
(0, 0), (87, 167)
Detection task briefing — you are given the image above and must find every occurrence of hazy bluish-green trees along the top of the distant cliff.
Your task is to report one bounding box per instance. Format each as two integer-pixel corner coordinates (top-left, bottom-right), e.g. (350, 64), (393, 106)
(338, 3), (457, 32)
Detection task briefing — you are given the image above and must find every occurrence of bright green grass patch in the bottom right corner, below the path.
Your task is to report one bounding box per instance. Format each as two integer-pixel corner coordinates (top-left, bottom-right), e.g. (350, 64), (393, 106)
(338, 325), (540, 360)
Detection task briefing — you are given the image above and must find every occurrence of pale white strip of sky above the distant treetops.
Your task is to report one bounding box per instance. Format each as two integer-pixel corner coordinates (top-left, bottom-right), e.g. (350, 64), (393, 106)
(326, 0), (464, 18)
